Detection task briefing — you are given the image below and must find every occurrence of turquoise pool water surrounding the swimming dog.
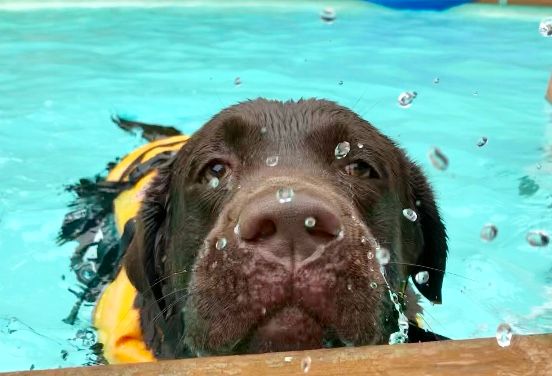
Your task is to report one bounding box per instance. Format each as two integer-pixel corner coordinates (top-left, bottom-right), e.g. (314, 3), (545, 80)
(0, 1), (552, 371)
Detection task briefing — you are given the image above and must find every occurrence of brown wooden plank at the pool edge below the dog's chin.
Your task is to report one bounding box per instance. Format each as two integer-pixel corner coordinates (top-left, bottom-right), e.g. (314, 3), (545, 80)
(4, 334), (552, 376)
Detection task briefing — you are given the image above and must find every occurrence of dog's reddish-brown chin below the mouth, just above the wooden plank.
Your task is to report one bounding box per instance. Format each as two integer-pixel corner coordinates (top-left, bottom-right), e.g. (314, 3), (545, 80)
(243, 307), (325, 353)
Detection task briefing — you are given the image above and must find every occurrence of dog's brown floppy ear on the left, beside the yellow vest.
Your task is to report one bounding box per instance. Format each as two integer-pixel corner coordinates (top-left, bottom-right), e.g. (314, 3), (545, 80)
(124, 163), (172, 299)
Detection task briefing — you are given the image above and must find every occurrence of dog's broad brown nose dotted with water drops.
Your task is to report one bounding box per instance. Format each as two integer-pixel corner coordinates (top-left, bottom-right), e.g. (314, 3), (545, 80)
(238, 192), (342, 262)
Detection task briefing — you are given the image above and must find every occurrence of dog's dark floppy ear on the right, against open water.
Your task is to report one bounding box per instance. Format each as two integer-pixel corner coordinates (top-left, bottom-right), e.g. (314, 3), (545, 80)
(409, 163), (448, 304)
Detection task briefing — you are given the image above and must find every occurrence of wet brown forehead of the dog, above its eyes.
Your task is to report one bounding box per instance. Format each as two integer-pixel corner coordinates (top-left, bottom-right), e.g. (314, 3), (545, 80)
(183, 99), (398, 172)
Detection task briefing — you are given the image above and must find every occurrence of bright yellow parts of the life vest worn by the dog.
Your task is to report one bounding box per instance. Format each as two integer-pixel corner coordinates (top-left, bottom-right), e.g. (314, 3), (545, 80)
(93, 136), (189, 364)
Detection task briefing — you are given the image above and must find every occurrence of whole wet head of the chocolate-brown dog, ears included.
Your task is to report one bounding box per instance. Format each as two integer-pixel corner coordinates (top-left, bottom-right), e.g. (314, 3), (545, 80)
(125, 99), (447, 357)
